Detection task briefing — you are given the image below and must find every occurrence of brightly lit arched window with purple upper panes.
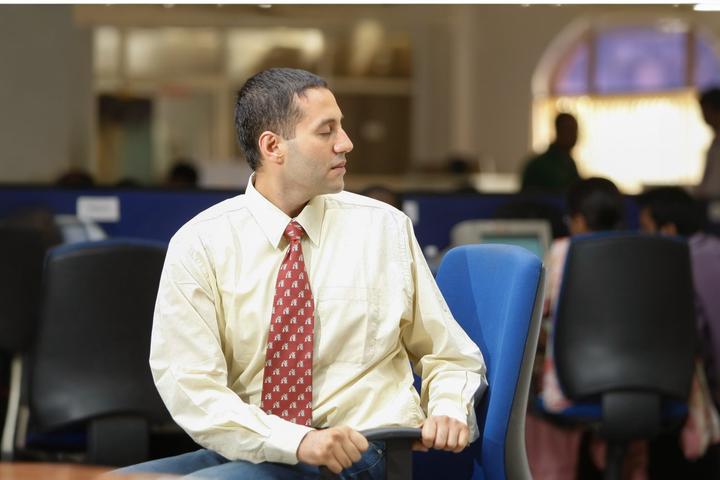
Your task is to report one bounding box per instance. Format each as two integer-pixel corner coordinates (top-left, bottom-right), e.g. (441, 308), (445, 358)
(532, 19), (720, 193)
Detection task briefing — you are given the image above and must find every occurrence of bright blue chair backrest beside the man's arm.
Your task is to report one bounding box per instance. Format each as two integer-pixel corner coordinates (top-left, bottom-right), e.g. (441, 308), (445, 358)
(415, 245), (543, 479)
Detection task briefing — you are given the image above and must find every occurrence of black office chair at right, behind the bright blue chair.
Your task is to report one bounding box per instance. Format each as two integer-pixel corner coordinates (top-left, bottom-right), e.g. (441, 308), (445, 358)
(554, 233), (696, 479)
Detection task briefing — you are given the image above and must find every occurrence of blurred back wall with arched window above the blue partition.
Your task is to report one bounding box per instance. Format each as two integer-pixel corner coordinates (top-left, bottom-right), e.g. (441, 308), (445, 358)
(0, 5), (720, 194)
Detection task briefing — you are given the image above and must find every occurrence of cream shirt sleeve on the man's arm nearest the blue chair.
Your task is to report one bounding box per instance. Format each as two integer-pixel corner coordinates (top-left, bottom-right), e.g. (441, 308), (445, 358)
(402, 219), (487, 441)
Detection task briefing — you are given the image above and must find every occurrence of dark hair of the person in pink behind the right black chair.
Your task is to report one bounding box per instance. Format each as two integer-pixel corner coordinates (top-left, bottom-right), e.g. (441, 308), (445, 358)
(567, 177), (625, 232)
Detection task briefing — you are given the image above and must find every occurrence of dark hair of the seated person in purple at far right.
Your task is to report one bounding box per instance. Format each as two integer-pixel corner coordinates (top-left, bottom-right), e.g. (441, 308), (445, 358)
(637, 187), (703, 236)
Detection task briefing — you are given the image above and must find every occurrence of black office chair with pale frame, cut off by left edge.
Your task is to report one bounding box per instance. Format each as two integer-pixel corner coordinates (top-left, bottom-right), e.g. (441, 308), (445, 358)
(0, 227), (46, 460)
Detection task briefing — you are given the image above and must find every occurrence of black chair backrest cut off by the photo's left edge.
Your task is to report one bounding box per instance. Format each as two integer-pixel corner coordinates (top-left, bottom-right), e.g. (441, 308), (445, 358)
(0, 227), (46, 354)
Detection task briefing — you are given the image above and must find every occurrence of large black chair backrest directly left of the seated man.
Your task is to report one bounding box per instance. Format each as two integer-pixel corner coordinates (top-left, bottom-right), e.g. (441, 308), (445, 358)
(29, 240), (169, 429)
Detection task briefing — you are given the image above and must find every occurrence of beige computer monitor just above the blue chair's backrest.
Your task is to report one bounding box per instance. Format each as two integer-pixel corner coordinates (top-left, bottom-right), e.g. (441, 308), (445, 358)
(450, 220), (552, 258)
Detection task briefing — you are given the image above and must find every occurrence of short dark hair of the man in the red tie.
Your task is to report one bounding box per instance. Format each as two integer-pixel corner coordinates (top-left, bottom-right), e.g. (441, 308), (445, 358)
(235, 68), (327, 170)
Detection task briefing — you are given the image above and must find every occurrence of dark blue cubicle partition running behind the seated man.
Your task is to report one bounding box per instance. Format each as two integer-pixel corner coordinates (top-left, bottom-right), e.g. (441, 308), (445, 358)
(0, 186), (637, 250)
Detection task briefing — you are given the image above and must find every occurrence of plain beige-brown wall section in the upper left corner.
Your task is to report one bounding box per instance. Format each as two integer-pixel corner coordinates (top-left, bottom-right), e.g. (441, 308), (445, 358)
(0, 5), (93, 182)
